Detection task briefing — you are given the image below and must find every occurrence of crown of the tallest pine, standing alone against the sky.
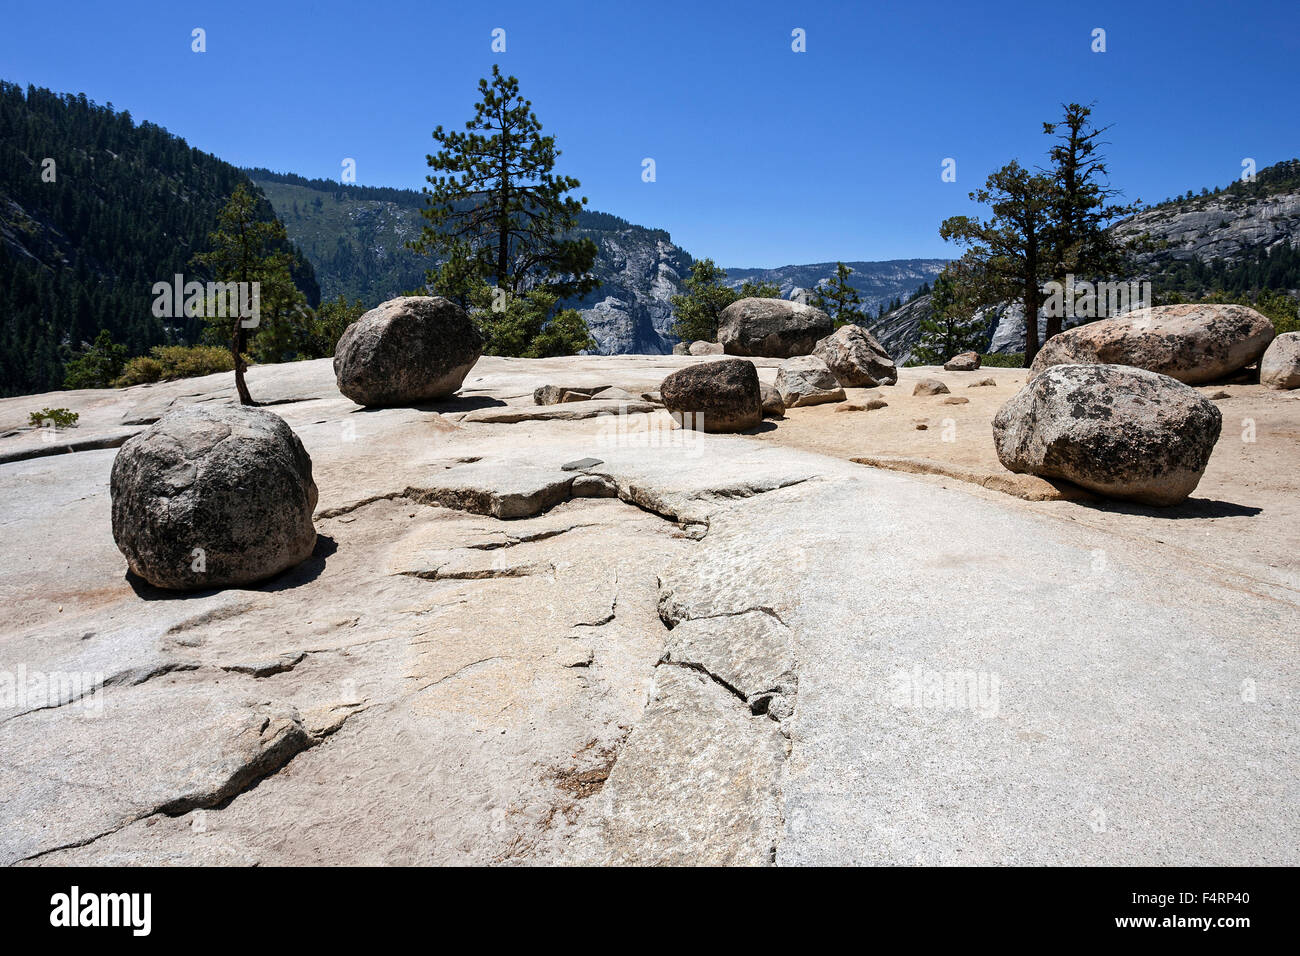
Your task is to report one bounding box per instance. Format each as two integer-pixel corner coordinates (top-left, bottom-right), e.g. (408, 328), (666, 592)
(411, 65), (597, 300)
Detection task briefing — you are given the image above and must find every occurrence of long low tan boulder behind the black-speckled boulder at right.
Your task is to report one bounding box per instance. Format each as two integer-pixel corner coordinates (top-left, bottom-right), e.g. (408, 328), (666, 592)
(1030, 304), (1274, 385)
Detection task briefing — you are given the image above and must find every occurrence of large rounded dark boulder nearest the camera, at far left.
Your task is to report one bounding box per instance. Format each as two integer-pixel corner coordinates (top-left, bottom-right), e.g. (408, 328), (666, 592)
(111, 406), (316, 591)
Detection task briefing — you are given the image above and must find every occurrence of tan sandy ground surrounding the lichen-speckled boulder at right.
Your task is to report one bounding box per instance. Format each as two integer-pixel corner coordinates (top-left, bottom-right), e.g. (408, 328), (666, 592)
(755, 367), (1300, 596)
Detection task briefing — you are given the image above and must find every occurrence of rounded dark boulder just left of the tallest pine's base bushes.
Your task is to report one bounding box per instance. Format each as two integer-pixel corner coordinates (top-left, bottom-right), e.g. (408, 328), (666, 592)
(334, 295), (482, 406)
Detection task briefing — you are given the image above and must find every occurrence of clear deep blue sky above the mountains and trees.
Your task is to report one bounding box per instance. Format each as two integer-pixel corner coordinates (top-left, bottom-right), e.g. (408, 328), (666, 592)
(0, 0), (1300, 267)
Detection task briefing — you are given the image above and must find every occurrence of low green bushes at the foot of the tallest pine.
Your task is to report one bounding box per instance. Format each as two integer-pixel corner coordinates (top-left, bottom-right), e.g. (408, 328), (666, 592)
(468, 284), (595, 359)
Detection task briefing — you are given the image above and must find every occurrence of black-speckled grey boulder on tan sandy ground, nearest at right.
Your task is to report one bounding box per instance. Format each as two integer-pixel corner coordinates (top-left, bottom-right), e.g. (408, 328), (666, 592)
(993, 365), (1222, 506)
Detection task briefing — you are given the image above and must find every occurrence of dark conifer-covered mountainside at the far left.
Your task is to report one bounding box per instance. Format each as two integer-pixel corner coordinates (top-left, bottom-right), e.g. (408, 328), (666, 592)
(0, 82), (320, 395)
